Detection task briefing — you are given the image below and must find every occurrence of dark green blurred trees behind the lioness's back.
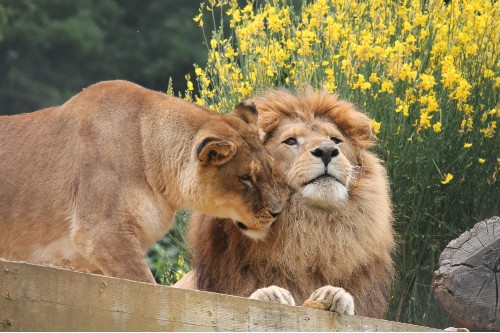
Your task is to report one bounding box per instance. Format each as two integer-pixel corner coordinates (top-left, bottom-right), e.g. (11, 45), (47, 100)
(0, 0), (207, 114)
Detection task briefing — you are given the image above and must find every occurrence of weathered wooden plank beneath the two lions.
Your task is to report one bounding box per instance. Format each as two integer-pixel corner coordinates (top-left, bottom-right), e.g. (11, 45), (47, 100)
(0, 261), (437, 331)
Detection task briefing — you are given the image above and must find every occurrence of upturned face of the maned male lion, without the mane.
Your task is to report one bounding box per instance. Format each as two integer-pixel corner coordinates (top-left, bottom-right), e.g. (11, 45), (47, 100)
(266, 118), (354, 209)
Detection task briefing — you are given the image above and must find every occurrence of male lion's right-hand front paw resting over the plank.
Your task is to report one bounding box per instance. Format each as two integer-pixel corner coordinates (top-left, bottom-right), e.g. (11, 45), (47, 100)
(304, 286), (354, 315)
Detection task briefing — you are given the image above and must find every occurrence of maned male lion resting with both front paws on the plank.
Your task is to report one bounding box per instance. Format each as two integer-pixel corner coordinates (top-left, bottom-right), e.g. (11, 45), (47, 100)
(176, 88), (395, 317)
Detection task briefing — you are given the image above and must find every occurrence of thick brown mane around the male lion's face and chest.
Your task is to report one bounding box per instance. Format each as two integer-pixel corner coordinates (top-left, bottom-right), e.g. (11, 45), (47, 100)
(184, 87), (395, 317)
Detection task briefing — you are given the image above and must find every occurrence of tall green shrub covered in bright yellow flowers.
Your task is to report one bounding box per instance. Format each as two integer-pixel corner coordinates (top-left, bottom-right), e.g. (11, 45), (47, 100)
(178, 0), (500, 326)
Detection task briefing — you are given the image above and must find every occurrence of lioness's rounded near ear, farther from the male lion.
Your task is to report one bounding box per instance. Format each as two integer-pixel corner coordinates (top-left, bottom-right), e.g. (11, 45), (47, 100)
(196, 137), (237, 165)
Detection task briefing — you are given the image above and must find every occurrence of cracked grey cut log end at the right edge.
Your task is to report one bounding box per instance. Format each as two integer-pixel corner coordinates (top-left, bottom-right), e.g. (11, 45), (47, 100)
(433, 216), (500, 331)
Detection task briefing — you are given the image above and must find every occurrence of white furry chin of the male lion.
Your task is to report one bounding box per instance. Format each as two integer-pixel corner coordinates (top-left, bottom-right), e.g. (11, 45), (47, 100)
(301, 177), (349, 209)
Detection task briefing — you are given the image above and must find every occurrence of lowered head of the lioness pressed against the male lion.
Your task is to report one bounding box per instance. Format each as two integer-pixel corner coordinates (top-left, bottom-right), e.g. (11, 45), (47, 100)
(192, 101), (287, 239)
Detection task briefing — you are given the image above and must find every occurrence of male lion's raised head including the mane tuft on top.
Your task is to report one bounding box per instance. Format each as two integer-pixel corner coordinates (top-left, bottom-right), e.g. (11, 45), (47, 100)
(257, 88), (372, 209)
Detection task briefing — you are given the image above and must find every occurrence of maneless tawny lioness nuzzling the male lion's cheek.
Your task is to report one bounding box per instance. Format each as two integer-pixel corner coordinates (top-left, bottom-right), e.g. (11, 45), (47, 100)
(0, 81), (281, 283)
